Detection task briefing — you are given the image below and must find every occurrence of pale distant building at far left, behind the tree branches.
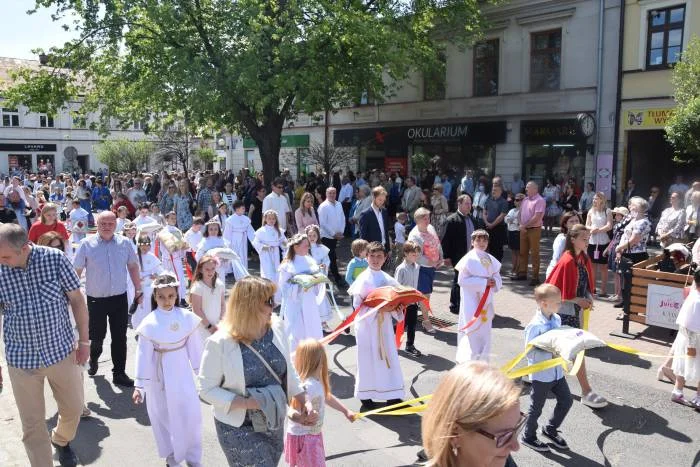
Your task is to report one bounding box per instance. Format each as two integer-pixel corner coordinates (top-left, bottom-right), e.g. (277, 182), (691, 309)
(0, 58), (145, 175)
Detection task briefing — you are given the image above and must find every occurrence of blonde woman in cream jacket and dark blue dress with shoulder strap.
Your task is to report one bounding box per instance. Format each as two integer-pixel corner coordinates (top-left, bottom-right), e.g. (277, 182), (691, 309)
(197, 276), (318, 467)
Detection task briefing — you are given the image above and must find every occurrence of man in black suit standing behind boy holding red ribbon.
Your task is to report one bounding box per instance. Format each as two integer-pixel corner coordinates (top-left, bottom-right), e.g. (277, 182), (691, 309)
(442, 193), (484, 314)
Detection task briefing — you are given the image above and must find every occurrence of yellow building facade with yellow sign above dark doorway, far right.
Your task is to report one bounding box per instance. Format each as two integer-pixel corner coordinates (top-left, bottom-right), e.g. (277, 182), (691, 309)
(617, 0), (700, 195)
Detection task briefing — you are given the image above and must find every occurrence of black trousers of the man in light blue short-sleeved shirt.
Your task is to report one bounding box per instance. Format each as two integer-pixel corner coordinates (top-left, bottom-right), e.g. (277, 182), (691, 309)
(87, 293), (129, 375)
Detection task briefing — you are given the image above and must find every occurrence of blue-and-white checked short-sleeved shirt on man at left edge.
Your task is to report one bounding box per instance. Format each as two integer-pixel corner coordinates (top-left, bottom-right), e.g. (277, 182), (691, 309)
(0, 246), (80, 370)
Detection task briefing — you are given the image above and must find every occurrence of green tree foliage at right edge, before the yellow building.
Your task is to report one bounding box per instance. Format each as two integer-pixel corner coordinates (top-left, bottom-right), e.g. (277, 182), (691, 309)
(666, 36), (700, 163)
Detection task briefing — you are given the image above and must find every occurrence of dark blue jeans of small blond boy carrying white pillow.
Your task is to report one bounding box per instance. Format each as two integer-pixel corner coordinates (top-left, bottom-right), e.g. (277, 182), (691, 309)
(523, 377), (574, 440)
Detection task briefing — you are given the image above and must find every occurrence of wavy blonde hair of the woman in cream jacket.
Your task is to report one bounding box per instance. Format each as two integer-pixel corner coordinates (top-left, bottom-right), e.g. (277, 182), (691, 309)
(218, 276), (277, 342)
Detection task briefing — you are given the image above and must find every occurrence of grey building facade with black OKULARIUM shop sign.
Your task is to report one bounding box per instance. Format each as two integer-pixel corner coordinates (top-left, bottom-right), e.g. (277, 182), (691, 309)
(234, 0), (620, 197)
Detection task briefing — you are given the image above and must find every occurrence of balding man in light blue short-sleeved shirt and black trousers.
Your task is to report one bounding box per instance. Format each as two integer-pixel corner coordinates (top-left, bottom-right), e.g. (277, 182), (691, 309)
(73, 211), (142, 387)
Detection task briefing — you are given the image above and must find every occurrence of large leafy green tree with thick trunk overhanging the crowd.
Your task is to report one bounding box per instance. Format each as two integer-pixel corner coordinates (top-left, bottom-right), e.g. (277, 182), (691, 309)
(6, 0), (488, 183)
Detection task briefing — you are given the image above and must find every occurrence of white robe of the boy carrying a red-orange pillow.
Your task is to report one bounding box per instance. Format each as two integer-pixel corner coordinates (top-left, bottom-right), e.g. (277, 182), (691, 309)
(348, 269), (406, 400)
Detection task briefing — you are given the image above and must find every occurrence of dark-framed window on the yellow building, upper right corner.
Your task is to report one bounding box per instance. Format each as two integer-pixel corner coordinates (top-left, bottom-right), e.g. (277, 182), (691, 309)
(646, 5), (686, 69)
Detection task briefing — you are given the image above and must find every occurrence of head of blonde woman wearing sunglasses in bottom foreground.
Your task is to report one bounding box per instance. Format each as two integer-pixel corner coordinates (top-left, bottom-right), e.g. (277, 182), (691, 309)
(422, 361), (526, 467)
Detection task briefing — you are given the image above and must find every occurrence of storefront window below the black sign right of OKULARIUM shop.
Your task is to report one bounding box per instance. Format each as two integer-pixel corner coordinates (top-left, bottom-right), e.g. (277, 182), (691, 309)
(523, 144), (586, 191)
